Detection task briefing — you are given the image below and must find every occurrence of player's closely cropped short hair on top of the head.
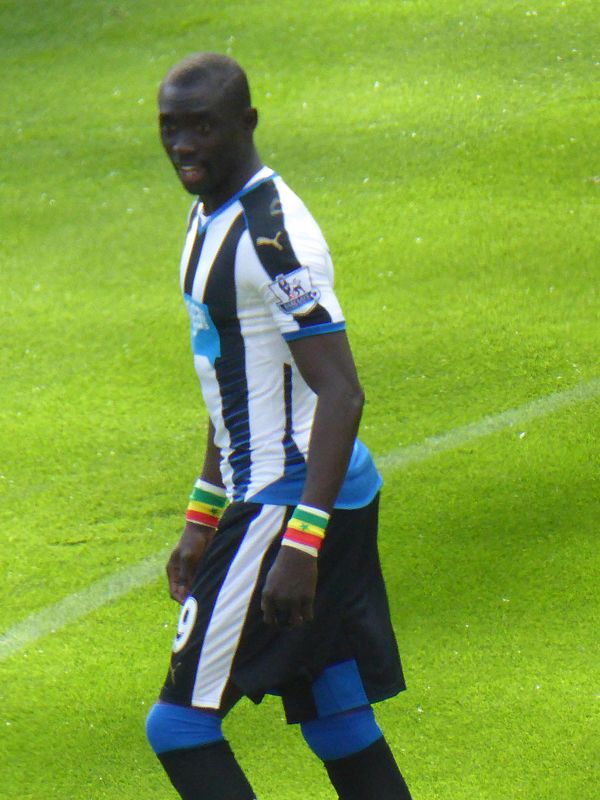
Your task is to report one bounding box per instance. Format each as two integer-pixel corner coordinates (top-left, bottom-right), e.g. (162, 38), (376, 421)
(161, 53), (252, 111)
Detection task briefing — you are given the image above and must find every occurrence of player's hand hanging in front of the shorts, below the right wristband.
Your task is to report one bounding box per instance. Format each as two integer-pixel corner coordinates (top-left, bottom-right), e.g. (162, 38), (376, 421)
(261, 546), (317, 628)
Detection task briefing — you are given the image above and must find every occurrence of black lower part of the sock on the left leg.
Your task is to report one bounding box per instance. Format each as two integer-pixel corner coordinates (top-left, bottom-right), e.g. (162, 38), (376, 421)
(158, 741), (256, 800)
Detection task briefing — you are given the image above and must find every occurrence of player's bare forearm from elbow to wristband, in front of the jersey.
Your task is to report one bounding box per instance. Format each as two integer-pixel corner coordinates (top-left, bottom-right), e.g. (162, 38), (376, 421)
(301, 385), (364, 512)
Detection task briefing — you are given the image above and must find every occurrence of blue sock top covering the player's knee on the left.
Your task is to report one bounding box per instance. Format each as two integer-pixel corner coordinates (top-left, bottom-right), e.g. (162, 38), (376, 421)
(146, 702), (223, 755)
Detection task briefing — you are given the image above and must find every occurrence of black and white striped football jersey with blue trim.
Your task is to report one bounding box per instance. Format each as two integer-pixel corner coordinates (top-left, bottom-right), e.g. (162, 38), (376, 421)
(181, 167), (381, 508)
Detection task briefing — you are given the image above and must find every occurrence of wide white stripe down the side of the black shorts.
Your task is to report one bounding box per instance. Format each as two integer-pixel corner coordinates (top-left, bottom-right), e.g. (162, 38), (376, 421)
(192, 505), (286, 708)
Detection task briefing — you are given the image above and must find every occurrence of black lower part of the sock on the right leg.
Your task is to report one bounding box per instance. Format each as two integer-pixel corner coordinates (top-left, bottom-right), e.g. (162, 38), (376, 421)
(324, 736), (411, 800)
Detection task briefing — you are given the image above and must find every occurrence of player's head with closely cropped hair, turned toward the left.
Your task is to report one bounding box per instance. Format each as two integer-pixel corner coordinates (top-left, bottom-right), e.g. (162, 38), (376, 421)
(158, 53), (258, 201)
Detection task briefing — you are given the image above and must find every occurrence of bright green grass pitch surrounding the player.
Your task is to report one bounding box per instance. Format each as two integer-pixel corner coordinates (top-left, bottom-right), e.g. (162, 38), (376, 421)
(0, 0), (600, 800)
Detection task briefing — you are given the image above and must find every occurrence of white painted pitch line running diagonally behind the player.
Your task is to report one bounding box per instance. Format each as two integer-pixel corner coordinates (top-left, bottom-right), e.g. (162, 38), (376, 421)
(0, 378), (600, 661)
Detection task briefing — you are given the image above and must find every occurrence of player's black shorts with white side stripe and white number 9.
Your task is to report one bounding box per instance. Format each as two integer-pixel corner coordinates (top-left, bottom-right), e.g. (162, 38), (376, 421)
(161, 497), (405, 722)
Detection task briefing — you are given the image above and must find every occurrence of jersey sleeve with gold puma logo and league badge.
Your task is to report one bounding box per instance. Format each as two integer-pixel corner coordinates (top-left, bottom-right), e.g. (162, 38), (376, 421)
(237, 182), (345, 341)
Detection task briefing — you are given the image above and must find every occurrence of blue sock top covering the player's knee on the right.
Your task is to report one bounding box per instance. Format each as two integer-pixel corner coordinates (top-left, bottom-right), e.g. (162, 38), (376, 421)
(300, 706), (383, 761)
